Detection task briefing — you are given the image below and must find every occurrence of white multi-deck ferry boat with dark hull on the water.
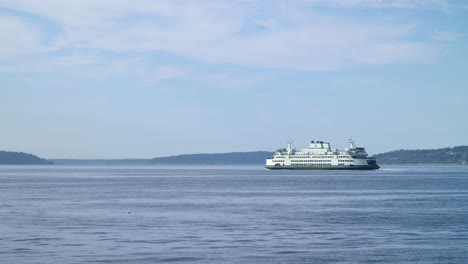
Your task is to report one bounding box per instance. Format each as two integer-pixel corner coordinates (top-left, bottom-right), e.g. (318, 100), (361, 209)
(265, 139), (380, 170)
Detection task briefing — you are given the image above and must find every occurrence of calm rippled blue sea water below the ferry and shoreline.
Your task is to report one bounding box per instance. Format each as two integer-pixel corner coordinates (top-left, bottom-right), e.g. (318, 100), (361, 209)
(0, 166), (468, 263)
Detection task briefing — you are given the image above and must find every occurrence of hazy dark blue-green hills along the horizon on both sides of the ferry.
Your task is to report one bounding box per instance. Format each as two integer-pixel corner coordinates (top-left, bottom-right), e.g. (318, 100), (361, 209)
(0, 146), (468, 165)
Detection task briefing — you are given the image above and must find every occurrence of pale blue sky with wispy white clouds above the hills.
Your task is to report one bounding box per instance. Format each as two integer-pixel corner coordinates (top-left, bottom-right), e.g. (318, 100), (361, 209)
(0, 0), (468, 159)
